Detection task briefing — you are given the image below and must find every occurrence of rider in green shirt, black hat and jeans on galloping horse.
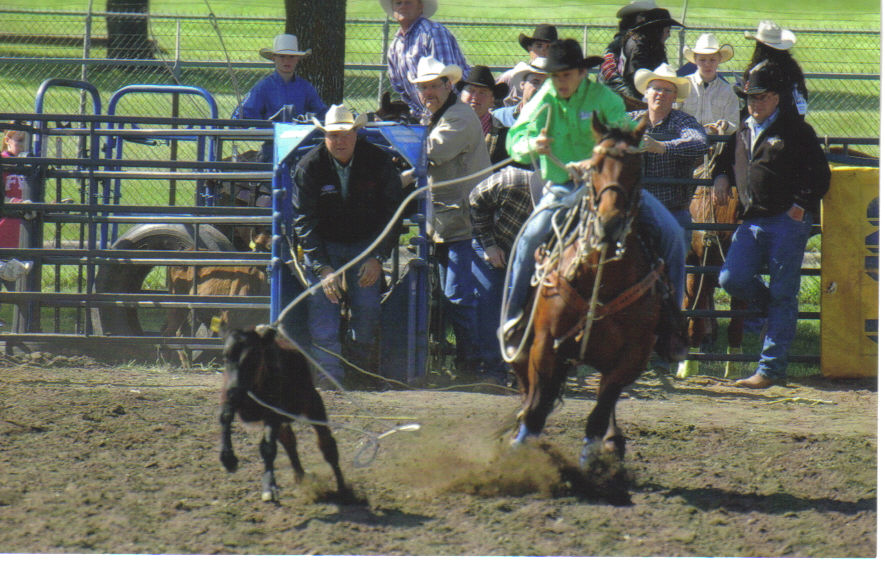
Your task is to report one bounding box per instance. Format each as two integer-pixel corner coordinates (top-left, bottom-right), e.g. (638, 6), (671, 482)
(502, 39), (685, 360)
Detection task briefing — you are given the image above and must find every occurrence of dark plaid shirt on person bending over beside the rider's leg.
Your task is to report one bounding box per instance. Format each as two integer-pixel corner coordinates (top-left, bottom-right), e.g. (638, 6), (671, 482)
(469, 166), (534, 255)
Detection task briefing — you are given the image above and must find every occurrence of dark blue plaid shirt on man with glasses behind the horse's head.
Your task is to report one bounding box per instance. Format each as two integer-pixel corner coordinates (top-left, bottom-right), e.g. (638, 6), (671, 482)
(630, 110), (707, 211)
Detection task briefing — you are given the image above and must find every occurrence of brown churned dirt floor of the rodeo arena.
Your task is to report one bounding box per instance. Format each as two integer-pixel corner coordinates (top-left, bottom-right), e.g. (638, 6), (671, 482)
(0, 355), (878, 557)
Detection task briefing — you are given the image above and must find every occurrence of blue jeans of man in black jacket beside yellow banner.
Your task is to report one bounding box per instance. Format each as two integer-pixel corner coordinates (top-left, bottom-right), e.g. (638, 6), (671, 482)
(719, 212), (811, 380)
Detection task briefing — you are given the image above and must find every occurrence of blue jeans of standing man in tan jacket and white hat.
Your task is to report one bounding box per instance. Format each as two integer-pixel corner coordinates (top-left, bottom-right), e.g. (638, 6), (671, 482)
(436, 239), (479, 362)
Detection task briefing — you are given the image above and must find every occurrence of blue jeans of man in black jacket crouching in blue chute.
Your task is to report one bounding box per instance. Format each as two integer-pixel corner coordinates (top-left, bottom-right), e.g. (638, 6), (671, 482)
(307, 241), (383, 382)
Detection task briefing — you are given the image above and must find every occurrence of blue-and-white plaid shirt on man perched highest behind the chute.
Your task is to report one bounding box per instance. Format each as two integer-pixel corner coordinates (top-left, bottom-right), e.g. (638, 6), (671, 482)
(387, 16), (470, 118)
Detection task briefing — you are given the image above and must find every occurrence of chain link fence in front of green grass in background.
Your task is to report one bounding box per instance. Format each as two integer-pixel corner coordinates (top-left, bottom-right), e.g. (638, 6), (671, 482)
(0, 10), (879, 164)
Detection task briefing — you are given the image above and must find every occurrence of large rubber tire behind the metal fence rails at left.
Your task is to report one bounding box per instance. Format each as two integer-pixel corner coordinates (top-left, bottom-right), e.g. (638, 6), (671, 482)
(92, 223), (235, 336)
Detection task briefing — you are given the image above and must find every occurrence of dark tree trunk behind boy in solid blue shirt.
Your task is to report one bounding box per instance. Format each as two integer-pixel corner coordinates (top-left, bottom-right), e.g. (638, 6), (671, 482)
(285, 0), (347, 104)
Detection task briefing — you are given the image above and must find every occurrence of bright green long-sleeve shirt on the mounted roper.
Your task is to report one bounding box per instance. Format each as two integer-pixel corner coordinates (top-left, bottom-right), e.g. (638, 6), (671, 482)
(507, 78), (629, 184)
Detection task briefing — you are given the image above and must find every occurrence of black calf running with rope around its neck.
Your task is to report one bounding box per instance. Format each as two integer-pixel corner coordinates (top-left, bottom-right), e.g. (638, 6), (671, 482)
(220, 325), (349, 501)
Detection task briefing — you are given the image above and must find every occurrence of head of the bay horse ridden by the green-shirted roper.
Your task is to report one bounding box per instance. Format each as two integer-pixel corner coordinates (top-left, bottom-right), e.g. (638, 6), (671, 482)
(587, 112), (648, 244)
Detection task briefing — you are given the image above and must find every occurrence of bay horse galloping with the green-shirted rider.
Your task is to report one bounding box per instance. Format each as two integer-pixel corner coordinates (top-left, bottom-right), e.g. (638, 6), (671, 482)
(504, 114), (666, 470)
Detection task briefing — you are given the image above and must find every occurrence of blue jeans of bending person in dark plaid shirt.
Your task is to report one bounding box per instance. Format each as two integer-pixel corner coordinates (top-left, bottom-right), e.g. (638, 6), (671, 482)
(471, 239), (505, 372)
